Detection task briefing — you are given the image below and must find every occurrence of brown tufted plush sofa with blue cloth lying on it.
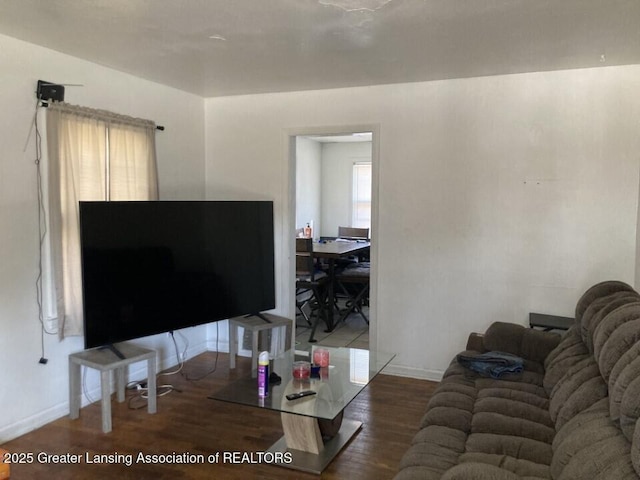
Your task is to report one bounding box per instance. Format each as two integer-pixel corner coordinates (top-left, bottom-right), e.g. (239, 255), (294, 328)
(395, 281), (640, 480)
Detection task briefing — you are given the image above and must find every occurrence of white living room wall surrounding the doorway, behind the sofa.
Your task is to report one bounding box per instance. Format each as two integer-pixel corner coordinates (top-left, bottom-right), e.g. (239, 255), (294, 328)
(205, 66), (640, 378)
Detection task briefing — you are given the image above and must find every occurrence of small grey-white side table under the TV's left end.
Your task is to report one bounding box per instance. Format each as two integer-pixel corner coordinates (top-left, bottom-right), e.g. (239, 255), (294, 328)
(69, 343), (157, 433)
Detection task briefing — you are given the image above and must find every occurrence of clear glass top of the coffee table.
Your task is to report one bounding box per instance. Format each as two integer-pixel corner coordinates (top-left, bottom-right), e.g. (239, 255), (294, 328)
(209, 347), (395, 420)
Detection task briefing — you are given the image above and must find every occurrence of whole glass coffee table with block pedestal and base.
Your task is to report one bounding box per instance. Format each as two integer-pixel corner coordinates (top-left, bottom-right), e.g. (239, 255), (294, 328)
(209, 347), (395, 474)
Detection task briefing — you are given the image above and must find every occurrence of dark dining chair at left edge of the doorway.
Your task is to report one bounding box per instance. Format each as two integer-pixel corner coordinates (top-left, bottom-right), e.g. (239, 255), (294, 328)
(296, 238), (329, 343)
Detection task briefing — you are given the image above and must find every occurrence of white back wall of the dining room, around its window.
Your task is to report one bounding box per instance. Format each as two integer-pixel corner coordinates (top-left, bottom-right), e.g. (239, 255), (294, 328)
(322, 142), (372, 237)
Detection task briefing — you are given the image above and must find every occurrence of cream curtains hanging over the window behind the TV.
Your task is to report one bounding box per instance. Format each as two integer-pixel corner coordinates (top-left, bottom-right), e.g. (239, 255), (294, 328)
(47, 103), (158, 338)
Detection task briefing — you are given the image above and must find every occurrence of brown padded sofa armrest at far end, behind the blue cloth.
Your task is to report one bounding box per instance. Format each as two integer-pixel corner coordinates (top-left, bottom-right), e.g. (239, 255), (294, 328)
(483, 322), (561, 363)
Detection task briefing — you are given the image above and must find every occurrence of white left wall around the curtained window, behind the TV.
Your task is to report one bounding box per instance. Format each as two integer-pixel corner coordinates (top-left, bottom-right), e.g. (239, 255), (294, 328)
(0, 36), (206, 443)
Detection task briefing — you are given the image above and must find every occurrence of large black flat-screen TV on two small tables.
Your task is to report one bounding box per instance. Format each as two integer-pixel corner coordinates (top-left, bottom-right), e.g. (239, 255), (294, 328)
(80, 201), (275, 348)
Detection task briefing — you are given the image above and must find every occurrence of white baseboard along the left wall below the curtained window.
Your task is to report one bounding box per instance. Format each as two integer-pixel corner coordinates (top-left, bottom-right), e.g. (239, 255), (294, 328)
(0, 342), (207, 445)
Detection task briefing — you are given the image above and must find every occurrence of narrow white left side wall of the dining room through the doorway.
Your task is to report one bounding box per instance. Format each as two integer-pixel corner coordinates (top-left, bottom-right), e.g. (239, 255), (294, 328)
(296, 137), (322, 238)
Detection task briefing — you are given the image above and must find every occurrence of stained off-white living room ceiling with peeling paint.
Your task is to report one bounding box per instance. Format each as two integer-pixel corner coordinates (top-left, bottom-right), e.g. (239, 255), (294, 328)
(0, 0), (640, 97)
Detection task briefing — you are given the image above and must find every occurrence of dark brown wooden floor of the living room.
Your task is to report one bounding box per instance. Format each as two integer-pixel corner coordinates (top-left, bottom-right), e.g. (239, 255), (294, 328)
(2, 352), (436, 480)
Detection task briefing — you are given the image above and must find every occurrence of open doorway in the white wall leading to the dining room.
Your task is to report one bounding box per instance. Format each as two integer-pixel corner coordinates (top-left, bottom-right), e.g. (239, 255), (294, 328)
(289, 127), (377, 348)
